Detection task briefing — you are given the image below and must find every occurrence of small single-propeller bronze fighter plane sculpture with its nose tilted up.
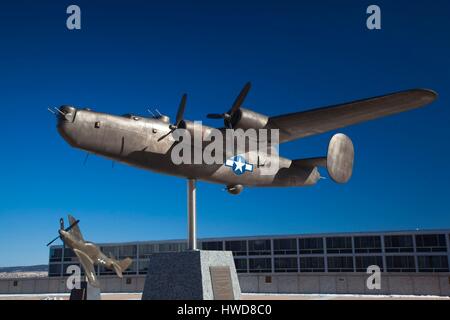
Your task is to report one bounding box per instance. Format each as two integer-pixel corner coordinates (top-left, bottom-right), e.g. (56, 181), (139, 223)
(47, 215), (133, 288)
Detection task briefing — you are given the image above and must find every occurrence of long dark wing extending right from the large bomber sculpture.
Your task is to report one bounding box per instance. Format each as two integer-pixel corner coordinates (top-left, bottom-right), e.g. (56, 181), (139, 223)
(267, 89), (437, 143)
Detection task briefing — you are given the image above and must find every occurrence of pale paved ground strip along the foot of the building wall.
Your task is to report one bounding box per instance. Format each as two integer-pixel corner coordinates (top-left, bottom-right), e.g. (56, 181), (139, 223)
(0, 293), (450, 300)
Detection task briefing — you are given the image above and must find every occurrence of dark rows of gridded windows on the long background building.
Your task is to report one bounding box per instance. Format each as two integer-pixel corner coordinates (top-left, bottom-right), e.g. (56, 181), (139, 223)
(49, 230), (450, 277)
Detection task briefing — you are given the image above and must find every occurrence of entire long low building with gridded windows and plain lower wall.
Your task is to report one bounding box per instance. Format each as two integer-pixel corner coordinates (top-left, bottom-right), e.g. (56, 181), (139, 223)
(0, 230), (450, 296)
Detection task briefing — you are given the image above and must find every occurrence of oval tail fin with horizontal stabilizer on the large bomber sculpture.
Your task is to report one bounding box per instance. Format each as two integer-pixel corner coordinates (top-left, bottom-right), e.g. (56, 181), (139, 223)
(293, 133), (355, 183)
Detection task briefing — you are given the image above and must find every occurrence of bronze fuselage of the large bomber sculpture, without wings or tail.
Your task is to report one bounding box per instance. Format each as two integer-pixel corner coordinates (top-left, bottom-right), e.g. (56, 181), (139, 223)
(58, 106), (320, 187)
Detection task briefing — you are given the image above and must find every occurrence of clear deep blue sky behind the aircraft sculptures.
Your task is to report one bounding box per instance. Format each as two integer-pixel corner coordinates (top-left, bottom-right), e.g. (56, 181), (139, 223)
(0, 0), (450, 266)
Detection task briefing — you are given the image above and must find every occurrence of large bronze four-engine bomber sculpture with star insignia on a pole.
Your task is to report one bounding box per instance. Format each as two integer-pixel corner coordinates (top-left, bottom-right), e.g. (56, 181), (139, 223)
(51, 83), (437, 194)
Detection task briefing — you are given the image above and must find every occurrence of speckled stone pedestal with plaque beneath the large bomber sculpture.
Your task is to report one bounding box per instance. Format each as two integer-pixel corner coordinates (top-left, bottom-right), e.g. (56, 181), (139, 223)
(142, 250), (241, 300)
